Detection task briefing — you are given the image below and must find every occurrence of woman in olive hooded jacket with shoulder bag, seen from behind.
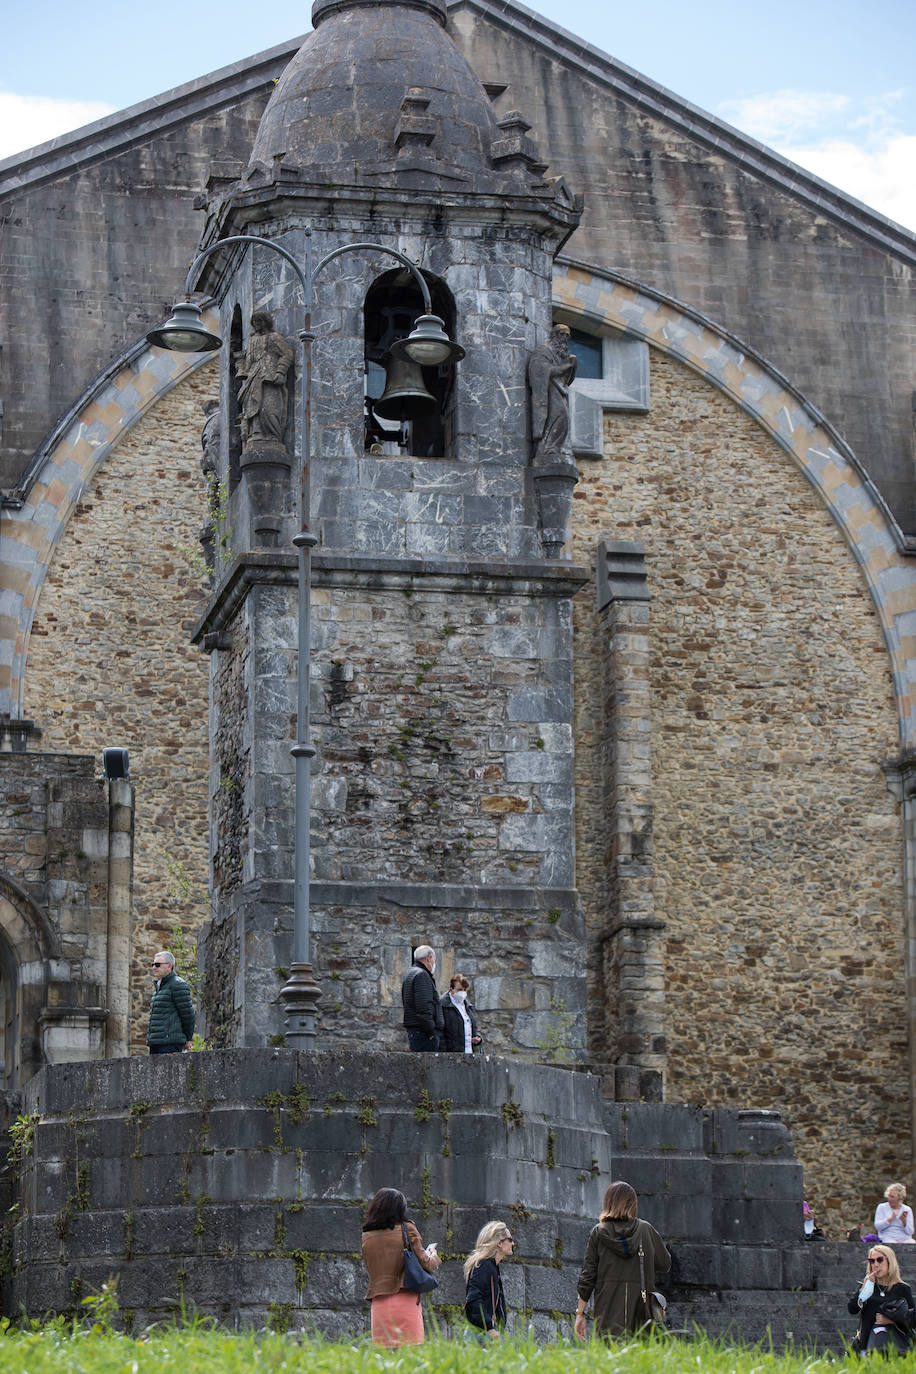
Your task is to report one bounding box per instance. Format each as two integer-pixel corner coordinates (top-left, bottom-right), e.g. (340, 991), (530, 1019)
(575, 1182), (672, 1341)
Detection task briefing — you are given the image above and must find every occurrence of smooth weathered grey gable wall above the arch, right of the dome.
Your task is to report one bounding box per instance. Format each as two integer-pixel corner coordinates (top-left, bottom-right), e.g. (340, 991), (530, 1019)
(449, 0), (916, 530)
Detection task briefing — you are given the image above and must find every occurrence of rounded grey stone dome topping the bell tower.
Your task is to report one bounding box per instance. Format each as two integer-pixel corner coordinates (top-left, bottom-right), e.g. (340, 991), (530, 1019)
(251, 0), (499, 190)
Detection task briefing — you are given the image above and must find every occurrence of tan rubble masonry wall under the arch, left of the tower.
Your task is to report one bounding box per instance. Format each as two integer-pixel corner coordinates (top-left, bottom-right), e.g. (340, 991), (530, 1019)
(25, 368), (213, 1044)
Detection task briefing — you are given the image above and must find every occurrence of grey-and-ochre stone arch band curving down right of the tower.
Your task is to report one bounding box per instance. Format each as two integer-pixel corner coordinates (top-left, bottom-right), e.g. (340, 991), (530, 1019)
(553, 258), (916, 752)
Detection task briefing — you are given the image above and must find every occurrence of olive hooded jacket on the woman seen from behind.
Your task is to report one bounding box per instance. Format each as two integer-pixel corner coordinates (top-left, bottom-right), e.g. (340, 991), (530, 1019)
(578, 1217), (672, 1336)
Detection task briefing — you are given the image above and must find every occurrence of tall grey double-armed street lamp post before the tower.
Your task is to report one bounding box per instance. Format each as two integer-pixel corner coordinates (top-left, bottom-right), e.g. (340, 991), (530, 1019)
(153, 227), (464, 1050)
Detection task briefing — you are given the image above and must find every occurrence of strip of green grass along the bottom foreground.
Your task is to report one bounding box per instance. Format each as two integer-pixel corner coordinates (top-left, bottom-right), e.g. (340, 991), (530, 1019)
(0, 1318), (873, 1374)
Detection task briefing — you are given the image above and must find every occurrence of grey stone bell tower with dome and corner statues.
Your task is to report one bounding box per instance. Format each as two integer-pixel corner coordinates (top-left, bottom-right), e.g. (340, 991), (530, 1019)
(190, 0), (585, 1058)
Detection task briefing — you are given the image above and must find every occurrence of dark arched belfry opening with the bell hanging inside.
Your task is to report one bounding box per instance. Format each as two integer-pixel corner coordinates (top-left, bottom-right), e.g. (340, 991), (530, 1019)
(364, 268), (455, 458)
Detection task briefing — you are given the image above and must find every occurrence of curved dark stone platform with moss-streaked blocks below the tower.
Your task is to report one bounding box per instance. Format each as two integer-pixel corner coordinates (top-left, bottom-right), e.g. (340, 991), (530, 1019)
(0, 1050), (862, 1348)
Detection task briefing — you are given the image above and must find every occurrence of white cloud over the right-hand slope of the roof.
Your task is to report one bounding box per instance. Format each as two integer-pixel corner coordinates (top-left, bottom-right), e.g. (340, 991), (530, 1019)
(715, 91), (916, 229)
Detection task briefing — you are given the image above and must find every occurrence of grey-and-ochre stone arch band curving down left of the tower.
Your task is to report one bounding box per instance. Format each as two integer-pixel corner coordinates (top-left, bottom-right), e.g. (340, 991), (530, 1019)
(0, 324), (218, 720)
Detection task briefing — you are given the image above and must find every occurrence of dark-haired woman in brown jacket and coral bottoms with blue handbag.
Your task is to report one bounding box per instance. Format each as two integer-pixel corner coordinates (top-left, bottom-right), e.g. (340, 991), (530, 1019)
(363, 1189), (442, 1347)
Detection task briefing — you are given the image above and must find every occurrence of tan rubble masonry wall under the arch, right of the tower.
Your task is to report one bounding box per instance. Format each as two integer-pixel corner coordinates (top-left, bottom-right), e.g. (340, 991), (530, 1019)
(573, 353), (909, 1235)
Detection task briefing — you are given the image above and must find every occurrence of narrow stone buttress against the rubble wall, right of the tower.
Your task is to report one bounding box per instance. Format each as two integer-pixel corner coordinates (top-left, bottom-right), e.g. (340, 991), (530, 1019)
(597, 543), (666, 1101)
